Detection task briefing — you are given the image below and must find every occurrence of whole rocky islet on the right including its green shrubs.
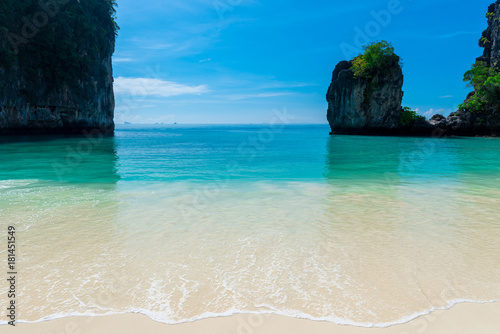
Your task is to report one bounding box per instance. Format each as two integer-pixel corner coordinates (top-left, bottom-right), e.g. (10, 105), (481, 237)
(326, 0), (500, 136)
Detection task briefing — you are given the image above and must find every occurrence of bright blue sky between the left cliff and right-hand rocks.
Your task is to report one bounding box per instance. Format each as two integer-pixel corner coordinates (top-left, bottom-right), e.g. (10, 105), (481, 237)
(113, 0), (493, 124)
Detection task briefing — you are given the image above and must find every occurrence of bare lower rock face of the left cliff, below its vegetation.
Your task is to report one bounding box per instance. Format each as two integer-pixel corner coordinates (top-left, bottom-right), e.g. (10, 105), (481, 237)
(0, 49), (114, 134)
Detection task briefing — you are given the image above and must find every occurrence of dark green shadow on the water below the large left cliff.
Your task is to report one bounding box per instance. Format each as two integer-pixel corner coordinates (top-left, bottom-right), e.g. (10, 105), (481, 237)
(0, 135), (120, 185)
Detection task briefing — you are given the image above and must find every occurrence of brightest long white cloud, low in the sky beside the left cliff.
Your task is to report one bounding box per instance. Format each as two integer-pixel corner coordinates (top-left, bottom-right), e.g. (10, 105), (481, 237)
(114, 77), (208, 97)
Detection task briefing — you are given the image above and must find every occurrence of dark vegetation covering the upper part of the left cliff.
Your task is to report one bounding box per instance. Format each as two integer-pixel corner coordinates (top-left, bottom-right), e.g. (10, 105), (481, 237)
(0, 0), (118, 89)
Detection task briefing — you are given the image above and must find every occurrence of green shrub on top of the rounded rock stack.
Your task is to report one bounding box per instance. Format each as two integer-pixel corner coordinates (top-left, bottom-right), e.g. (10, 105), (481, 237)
(351, 41), (400, 79)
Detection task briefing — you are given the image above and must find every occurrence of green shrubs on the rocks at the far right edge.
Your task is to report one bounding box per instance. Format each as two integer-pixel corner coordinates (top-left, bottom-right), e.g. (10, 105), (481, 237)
(458, 62), (500, 112)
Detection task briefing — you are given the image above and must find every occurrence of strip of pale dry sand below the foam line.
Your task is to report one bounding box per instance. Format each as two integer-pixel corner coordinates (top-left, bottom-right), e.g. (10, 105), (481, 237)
(0, 302), (500, 334)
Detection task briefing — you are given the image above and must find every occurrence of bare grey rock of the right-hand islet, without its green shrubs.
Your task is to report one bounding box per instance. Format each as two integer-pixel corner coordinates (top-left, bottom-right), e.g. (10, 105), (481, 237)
(326, 0), (500, 136)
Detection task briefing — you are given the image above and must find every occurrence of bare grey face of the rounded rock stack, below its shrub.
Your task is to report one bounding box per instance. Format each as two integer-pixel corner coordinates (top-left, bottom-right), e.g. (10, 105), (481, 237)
(326, 61), (403, 134)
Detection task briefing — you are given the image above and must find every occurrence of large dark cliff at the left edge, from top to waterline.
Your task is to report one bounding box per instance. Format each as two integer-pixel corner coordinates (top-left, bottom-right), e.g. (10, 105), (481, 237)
(0, 0), (116, 134)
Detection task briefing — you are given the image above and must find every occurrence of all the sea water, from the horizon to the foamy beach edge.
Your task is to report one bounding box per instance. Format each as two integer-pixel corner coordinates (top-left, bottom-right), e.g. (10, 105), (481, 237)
(0, 125), (500, 326)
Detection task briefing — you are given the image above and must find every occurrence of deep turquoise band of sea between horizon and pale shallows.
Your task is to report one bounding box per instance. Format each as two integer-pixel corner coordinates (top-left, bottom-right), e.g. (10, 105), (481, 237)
(0, 125), (500, 183)
